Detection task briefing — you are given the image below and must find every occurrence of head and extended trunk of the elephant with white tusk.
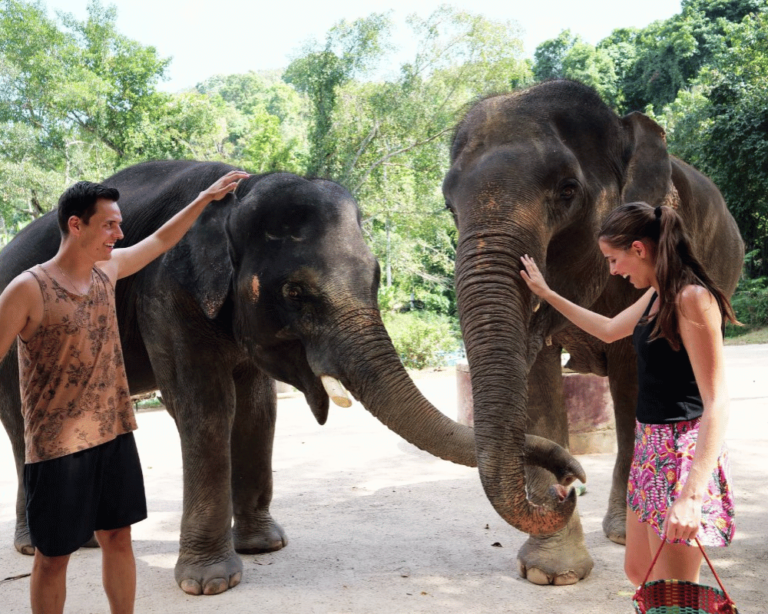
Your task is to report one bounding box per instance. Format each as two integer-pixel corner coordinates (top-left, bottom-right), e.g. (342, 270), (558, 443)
(164, 165), (583, 481)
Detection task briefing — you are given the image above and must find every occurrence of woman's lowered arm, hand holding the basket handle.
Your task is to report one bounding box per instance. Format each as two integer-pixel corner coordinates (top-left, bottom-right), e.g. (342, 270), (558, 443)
(664, 285), (729, 540)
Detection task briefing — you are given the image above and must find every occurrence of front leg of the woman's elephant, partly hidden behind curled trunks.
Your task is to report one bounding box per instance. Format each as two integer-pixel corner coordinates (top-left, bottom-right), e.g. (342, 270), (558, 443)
(517, 346), (594, 585)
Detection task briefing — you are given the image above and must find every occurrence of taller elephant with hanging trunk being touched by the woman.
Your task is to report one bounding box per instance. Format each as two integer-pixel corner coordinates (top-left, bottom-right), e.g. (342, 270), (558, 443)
(442, 80), (744, 584)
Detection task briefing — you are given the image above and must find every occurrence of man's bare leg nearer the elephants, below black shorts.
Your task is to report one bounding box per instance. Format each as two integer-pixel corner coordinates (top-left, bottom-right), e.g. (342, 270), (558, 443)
(96, 526), (136, 614)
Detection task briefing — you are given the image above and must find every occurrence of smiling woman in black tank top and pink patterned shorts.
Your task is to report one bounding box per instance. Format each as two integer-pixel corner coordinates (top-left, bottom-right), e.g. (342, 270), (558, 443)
(521, 203), (736, 586)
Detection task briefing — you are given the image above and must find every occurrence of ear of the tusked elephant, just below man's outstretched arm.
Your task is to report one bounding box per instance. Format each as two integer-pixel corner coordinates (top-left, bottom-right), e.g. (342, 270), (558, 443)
(163, 199), (234, 320)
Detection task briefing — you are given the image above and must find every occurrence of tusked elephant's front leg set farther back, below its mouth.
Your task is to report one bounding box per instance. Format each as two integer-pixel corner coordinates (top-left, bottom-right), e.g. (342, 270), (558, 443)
(231, 365), (288, 554)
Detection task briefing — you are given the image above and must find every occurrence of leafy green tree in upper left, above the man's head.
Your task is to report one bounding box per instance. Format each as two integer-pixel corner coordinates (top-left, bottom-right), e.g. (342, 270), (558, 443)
(0, 0), (221, 238)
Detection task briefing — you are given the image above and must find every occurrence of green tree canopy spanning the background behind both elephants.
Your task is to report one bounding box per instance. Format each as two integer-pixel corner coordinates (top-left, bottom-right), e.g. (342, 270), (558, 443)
(0, 0), (768, 348)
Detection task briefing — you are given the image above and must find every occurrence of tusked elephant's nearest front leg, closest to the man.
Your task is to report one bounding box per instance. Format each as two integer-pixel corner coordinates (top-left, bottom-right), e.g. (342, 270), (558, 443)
(150, 354), (243, 595)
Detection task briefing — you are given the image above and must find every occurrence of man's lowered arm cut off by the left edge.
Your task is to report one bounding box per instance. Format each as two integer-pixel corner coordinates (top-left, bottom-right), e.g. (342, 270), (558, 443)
(0, 273), (42, 362)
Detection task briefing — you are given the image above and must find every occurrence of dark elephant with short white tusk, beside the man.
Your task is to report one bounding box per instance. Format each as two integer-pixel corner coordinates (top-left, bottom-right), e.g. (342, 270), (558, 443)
(0, 161), (583, 594)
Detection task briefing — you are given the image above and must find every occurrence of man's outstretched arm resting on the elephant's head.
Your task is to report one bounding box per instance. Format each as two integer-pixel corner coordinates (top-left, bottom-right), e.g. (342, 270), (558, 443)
(98, 171), (249, 283)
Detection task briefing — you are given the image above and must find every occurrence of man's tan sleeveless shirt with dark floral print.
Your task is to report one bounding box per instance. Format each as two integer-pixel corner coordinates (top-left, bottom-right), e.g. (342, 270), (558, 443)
(18, 265), (136, 463)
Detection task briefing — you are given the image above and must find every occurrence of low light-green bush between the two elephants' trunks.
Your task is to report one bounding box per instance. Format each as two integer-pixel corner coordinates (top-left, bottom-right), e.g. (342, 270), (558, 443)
(383, 312), (461, 369)
